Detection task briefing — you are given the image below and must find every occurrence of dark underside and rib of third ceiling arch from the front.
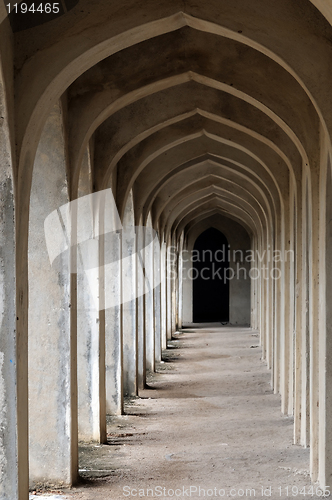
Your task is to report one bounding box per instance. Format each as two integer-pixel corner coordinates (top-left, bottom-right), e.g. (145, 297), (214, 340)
(96, 82), (308, 192)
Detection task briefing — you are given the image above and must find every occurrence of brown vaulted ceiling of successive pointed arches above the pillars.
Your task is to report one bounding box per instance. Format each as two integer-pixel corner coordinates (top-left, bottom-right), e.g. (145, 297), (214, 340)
(9, 0), (332, 242)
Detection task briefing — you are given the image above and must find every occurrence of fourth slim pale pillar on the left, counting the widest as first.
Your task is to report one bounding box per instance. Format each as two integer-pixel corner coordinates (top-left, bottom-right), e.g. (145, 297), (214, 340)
(121, 192), (138, 397)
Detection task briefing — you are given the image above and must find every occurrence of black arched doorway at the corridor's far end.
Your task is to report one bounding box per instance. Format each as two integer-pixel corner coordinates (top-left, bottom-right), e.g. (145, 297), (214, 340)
(192, 227), (229, 323)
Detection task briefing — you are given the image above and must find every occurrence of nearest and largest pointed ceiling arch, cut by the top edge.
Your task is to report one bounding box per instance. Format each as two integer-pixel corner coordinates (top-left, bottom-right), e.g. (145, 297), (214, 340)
(17, 0), (331, 195)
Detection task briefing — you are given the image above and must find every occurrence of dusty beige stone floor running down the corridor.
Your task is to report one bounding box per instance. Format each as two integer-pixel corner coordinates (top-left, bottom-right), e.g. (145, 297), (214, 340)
(34, 325), (326, 500)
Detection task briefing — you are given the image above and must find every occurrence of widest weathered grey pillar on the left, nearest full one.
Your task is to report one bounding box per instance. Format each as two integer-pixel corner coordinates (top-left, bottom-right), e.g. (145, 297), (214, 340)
(29, 104), (77, 484)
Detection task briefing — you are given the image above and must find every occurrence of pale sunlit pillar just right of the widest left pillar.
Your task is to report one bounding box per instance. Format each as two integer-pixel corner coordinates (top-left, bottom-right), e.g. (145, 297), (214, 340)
(75, 150), (106, 442)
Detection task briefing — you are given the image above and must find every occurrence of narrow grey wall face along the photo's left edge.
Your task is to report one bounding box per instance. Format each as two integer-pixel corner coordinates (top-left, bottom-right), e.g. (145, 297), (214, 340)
(0, 40), (17, 499)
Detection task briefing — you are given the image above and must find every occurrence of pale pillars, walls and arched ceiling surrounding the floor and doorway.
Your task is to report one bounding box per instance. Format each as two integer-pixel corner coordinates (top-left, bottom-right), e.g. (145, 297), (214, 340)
(0, 0), (332, 500)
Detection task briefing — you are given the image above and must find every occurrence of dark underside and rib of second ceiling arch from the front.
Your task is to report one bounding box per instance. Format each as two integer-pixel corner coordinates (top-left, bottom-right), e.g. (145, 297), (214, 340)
(65, 28), (318, 191)
